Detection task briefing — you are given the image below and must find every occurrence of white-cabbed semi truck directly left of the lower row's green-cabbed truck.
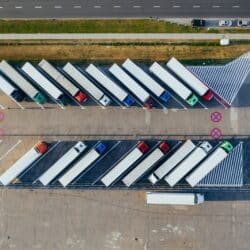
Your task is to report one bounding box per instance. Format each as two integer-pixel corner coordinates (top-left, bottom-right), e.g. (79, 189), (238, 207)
(164, 141), (212, 187)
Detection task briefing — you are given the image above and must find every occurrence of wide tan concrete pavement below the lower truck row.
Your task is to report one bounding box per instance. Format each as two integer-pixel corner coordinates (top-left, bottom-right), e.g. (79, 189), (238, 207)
(0, 189), (250, 250)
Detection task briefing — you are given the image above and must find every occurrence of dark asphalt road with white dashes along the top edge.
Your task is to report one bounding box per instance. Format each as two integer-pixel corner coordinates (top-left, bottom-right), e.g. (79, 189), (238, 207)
(0, 0), (250, 18)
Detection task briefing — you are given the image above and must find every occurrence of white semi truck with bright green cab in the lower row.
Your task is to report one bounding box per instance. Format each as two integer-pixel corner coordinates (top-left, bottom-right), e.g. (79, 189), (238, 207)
(186, 141), (233, 187)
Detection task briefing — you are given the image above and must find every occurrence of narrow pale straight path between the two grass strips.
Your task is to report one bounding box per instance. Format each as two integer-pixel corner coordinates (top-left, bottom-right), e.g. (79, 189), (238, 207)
(0, 33), (250, 40)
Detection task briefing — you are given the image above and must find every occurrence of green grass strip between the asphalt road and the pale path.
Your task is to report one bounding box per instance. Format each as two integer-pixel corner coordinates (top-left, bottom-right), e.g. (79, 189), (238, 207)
(0, 19), (205, 33)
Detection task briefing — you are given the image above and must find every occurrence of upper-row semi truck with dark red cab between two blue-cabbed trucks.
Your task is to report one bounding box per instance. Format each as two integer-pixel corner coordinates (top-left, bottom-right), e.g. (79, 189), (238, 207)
(109, 63), (154, 109)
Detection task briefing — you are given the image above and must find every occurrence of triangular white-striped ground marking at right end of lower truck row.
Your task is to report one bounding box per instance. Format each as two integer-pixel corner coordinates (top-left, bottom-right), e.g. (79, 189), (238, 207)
(197, 142), (243, 187)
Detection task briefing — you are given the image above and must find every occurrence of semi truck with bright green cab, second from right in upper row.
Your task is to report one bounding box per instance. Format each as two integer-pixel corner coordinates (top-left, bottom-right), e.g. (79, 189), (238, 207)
(149, 62), (198, 106)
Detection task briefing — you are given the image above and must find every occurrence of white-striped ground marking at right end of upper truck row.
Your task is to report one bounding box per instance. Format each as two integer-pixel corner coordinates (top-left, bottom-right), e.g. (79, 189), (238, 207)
(187, 52), (250, 105)
